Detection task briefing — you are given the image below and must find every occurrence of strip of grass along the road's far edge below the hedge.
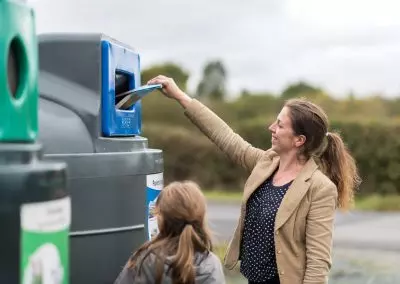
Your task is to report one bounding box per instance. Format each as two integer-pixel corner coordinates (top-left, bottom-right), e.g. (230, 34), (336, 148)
(204, 189), (400, 211)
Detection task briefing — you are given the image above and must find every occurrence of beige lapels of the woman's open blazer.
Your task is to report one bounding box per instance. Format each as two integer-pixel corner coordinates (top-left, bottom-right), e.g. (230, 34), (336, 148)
(242, 153), (318, 231)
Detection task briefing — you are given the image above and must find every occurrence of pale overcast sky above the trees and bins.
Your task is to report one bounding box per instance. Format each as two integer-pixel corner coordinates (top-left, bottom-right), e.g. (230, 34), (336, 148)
(28, 0), (400, 97)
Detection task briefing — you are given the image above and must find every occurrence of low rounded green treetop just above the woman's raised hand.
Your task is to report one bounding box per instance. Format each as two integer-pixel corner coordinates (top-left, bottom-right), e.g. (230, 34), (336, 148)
(141, 62), (189, 91)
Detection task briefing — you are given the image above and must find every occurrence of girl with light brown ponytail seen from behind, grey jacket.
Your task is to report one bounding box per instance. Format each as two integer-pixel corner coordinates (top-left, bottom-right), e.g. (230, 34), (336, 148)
(114, 181), (225, 284)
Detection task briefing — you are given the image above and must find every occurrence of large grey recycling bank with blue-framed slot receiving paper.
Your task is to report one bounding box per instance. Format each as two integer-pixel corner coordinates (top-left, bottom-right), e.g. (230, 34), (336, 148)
(39, 34), (163, 284)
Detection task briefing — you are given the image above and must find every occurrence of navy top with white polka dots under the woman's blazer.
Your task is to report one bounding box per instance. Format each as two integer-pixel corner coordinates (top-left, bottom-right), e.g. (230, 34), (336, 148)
(240, 177), (291, 282)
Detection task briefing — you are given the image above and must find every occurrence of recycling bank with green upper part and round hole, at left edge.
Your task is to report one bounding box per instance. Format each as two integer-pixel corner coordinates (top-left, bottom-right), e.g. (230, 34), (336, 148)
(0, 0), (71, 284)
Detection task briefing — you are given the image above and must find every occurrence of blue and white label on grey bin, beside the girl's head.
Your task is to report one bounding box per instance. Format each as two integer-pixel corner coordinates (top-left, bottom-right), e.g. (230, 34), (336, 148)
(146, 173), (164, 240)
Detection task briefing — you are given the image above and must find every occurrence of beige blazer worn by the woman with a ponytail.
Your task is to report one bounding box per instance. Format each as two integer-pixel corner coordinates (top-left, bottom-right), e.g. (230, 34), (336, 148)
(185, 99), (337, 284)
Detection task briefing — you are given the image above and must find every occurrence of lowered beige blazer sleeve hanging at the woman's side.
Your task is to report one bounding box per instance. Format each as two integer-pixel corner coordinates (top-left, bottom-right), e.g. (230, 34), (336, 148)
(303, 184), (337, 284)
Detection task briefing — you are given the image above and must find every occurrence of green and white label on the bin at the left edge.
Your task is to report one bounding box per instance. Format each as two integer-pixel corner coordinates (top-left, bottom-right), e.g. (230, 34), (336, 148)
(20, 197), (71, 284)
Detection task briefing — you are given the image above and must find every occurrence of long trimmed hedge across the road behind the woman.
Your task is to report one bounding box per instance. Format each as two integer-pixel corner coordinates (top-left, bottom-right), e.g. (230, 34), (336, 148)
(143, 117), (400, 195)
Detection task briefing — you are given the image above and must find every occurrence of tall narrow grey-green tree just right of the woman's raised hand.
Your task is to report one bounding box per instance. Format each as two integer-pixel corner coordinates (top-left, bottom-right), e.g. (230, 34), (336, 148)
(196, 60), (226, 100)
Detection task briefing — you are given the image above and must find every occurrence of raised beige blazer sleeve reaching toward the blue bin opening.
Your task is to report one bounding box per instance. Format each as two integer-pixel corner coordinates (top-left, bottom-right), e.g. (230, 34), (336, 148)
(185, 99), (265, 171)
